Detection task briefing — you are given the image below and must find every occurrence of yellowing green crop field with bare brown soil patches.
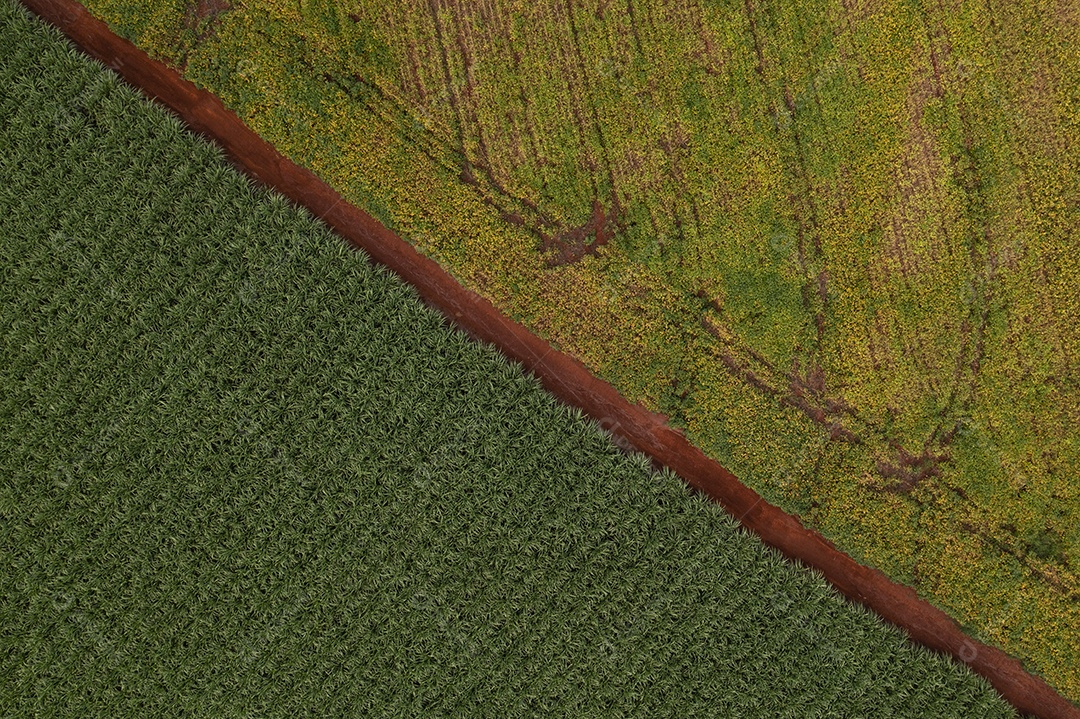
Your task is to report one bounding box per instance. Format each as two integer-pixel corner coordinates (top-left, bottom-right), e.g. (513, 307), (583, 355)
(78, 0), (1080, 701)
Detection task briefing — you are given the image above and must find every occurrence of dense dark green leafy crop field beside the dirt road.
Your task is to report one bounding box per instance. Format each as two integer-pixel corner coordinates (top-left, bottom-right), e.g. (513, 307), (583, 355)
(0, 0), (1012, 719)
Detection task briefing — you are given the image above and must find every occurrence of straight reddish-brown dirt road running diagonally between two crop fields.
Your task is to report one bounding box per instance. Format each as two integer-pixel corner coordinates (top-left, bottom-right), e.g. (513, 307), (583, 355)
(23, 0), (1080, 719)
